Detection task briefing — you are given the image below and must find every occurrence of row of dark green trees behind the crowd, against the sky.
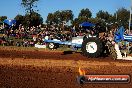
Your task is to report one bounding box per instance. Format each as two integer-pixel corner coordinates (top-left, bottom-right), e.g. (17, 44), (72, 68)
(0, 0), (130, 31)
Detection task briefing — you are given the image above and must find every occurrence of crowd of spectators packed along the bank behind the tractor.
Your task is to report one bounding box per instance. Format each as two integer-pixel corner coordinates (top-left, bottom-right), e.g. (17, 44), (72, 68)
(0, 24), (131, 47)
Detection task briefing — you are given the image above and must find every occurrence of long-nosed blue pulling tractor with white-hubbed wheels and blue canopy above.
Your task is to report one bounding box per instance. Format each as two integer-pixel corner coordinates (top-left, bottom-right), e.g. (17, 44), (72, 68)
(44, 22), (103, 58)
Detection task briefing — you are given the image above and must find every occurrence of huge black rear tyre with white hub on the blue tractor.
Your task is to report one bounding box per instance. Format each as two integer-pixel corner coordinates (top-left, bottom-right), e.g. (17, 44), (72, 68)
(82, 37), (103, 58)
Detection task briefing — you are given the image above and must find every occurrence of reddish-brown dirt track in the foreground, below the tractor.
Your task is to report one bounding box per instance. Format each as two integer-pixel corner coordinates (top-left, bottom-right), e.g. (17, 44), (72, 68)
(0, 47), (132, 88)
